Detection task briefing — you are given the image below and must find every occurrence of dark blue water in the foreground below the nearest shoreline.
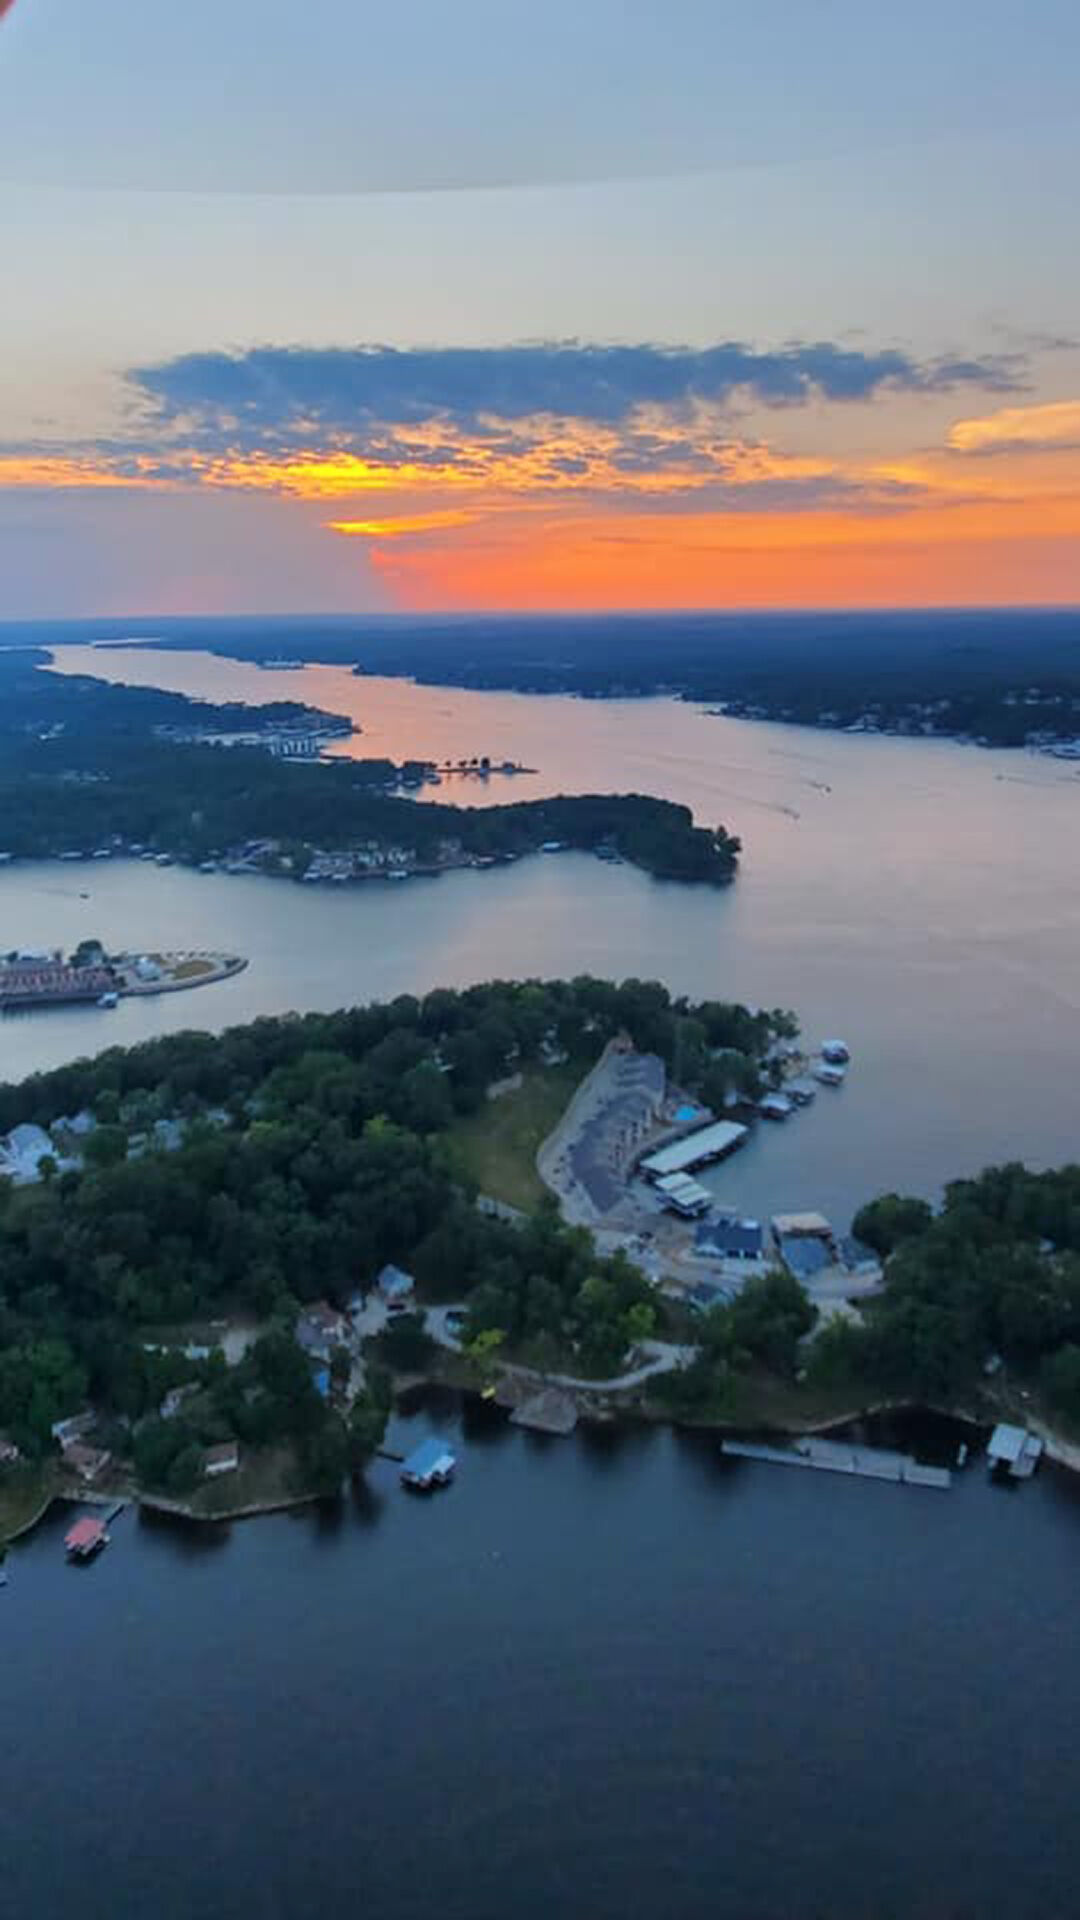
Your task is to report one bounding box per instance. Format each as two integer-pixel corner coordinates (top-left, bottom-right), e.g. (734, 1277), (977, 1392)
(0, 1413), (1080, 1920)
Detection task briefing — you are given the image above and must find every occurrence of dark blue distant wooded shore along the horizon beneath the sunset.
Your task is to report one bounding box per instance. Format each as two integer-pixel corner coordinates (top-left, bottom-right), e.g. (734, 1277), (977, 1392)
(10, 609), (1080, 745)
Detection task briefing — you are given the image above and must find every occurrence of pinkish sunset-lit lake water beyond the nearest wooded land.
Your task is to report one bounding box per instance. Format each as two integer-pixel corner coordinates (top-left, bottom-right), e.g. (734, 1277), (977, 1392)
(8, 647), (1080, 1223)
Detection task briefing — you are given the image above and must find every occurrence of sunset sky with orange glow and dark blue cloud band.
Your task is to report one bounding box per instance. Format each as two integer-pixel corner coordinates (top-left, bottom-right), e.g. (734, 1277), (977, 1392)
(0, 0), (1080, 618)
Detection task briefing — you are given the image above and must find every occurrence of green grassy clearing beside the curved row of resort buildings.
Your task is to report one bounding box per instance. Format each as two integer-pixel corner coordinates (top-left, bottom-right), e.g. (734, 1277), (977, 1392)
(444, 1064), (580, 1212)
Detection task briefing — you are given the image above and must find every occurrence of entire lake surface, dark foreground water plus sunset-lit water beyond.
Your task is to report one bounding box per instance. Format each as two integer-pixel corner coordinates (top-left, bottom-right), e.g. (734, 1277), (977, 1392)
(0, 655), (1080, 1920)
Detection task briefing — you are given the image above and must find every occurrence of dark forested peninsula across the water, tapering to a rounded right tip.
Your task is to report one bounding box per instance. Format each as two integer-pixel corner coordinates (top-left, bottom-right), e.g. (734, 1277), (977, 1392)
(0, 653), (740, 885)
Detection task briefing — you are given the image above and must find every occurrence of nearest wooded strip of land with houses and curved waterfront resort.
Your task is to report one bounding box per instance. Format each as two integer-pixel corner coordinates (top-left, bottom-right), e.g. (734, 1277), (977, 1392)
(0, 977), (1080, 1534)
